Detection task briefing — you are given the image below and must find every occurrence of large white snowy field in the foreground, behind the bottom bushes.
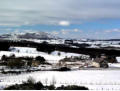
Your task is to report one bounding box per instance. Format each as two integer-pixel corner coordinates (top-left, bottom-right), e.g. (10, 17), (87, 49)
(0, 70), (120, 90)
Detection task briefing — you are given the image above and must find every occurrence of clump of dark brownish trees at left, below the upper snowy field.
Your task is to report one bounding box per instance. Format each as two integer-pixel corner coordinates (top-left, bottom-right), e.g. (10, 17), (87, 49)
(0, 55), (46, 68)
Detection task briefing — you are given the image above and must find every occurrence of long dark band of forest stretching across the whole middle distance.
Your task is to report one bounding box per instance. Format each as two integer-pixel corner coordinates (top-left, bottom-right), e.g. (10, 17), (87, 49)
(0, 41), (120, 62)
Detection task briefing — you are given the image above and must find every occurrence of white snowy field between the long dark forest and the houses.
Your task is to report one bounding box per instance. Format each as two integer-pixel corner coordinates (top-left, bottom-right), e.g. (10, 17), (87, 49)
(0, 47), (84, 63)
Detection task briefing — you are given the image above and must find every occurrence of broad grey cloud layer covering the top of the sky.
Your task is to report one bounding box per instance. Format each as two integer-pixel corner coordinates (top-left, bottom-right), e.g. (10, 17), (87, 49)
(0, 0), (120, 25)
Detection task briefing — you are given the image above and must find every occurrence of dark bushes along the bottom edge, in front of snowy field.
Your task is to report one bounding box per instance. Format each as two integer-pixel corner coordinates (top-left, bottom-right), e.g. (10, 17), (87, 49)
(5, 77), (88, 90)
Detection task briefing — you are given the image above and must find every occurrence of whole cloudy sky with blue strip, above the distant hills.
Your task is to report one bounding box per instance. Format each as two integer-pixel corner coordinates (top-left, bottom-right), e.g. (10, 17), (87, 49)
(0, 0), (120, 38)
